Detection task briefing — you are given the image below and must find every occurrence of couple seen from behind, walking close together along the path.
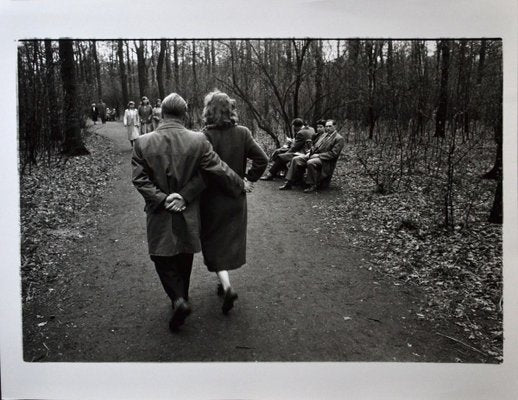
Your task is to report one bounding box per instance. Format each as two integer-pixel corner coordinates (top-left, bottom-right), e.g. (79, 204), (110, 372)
(132, 90), (268, 331)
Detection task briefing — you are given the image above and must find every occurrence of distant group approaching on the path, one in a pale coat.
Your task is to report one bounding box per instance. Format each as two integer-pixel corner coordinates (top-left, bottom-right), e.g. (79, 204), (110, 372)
(123, 96), (162, 146)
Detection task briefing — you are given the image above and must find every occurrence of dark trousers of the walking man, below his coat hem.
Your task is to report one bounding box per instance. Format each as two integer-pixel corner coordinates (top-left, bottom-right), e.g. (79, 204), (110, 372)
(151, 253), (194, 303)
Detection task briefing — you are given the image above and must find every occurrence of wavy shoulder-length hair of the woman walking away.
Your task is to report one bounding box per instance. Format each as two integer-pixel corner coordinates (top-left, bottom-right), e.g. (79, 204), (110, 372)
(203, 89), (238, 126)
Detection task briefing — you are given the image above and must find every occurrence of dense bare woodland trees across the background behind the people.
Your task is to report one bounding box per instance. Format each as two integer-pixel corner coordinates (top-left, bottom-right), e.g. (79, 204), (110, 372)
(18, 39), (502, 220)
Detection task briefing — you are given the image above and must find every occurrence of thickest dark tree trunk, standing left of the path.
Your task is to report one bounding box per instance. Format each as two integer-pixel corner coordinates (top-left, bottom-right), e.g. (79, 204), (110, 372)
(59, 39), (90, 157)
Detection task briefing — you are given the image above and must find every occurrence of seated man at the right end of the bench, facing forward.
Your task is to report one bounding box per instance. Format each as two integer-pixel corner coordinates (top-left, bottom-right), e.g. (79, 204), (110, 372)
(279, 119), (344, 193)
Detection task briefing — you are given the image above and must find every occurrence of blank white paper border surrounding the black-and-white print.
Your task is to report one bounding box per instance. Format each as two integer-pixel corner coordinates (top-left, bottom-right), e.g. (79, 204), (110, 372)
(0, 0), (518, 399)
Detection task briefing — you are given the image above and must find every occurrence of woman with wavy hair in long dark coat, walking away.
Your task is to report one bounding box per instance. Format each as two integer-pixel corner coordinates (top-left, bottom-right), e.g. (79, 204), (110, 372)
(200, 90), (268, 314)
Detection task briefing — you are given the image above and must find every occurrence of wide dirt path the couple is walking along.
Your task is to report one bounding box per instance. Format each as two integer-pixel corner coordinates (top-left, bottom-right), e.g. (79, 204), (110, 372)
(24, 122), (484, 362)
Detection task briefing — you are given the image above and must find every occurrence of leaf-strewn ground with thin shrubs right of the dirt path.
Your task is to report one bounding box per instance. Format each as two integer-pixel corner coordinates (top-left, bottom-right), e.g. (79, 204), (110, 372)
(319, 139), (503, 361)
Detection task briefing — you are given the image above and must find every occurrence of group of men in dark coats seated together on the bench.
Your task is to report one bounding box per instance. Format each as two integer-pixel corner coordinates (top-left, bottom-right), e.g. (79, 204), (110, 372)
(261, 118), (344, 193)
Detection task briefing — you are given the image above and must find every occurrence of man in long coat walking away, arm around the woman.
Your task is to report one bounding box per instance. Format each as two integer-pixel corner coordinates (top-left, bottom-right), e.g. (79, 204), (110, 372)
(132, 93), (244, 331)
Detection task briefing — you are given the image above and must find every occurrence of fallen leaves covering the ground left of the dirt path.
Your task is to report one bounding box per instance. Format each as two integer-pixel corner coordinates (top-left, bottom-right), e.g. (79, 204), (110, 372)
(20, 134), (119, 303)
